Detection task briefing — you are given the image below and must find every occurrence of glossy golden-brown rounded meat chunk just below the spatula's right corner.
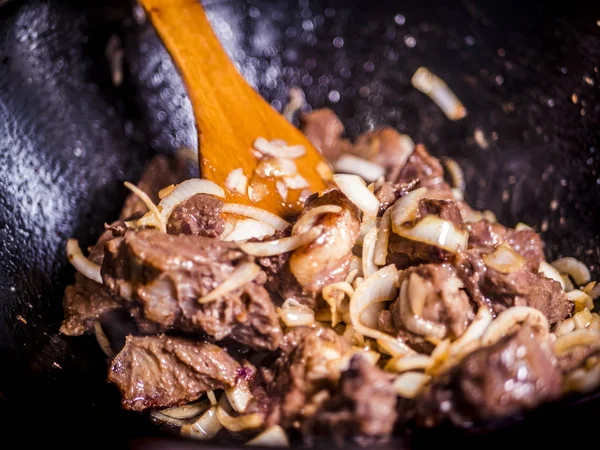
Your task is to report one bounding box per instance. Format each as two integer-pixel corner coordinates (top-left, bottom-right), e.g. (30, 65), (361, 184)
(281, 190), (360, 306)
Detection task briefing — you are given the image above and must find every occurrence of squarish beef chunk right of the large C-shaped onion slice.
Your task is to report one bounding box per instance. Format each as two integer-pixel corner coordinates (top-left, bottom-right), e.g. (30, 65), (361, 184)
(390, 264), (475, 338)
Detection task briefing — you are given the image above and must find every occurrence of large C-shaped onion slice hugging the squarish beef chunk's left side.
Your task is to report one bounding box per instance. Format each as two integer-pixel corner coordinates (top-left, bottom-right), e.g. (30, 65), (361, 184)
(350, 264), (413, 354)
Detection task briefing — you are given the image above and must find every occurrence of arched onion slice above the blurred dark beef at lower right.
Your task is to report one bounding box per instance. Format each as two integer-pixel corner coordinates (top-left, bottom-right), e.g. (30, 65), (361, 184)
(481, 306), (550, 345)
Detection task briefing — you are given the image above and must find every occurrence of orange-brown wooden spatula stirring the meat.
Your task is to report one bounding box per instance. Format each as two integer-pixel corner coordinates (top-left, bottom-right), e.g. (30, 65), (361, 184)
(140, 0), (329, 216)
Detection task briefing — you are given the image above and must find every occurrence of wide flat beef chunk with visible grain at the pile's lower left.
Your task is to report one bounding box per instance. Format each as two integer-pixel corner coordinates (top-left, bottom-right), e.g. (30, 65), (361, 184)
(108, 335), (241, 411)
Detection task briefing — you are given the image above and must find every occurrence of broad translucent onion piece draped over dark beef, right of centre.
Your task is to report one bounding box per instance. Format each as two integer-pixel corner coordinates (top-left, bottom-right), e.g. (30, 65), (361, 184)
(394, 215), (469, 253)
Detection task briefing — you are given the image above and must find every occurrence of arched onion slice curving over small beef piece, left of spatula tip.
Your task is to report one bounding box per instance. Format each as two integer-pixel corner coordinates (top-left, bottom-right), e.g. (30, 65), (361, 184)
(138, 178), (225, 231)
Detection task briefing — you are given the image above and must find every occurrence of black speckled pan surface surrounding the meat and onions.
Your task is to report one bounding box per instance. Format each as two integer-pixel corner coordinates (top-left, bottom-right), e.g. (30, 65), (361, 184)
(0, 0), (600, 448)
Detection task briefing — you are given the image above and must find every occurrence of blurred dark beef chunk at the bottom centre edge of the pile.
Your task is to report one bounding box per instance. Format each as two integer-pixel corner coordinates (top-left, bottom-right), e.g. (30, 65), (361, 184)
(302, 355), (397, 447)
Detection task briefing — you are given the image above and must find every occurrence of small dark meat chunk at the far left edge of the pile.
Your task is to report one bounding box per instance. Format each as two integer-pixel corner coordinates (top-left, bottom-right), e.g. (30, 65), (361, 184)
(60, 273), (120, 336)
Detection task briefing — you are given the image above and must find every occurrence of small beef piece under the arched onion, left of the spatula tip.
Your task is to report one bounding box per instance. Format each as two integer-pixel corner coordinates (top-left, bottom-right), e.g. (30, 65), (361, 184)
(167, 194), (225, 238)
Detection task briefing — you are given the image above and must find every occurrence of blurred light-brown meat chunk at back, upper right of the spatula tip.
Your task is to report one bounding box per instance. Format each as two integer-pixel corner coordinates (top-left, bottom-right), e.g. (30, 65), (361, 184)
(350, 127), (414, 178)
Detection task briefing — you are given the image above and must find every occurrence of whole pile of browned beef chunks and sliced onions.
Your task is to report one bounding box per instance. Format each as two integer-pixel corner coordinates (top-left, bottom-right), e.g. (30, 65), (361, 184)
(61, 96), (600, 445)
